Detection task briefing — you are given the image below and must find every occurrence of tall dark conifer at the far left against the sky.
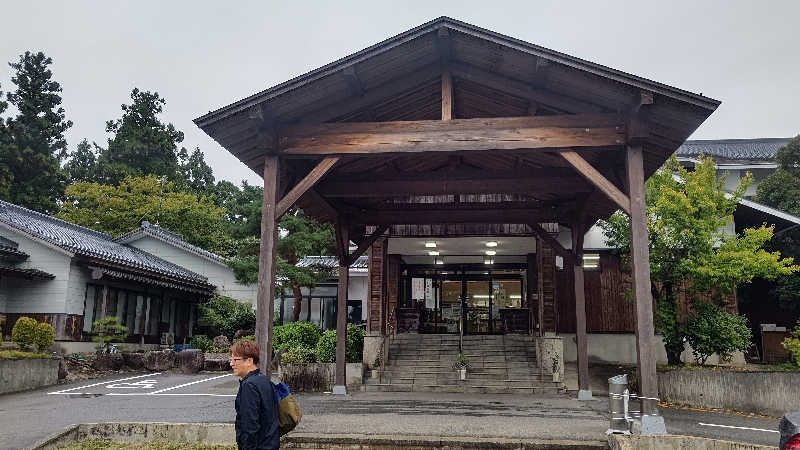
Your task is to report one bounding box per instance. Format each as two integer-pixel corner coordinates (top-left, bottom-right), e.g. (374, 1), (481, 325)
(0, 52), (72, 213)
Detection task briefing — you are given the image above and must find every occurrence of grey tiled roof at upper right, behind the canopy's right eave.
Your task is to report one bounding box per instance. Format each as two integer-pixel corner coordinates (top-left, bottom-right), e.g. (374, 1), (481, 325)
(675, 138), (791, 161)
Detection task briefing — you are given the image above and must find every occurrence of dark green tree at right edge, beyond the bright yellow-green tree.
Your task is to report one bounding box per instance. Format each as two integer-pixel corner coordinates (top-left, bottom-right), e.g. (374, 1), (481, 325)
(756, 135), (800, 314)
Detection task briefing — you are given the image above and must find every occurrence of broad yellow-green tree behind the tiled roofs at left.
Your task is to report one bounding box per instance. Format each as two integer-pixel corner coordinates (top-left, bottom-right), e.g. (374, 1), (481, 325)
(58, 175), (232, 256)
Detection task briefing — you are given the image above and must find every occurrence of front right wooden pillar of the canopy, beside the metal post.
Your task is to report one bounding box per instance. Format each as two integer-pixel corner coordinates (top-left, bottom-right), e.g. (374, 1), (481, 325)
(625, 146), (658, 414)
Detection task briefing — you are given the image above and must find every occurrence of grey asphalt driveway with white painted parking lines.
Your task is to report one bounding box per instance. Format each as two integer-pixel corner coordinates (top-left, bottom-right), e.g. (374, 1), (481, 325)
(0, 373), (778, 449)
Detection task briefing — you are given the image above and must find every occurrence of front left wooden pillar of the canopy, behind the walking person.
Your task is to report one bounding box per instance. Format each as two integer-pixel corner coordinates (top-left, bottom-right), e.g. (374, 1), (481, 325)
(255, 155), (279, 376)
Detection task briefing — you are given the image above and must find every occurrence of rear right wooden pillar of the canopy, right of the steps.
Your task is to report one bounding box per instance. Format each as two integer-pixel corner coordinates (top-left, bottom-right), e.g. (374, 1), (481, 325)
(572, 221), (592, 400)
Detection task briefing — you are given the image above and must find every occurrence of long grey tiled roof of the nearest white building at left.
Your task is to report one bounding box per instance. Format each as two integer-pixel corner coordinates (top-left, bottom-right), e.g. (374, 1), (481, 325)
(0, 200), (208, 285)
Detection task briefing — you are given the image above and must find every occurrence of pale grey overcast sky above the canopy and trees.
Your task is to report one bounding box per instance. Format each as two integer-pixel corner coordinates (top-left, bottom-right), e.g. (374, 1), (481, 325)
(0, 0), (800, 183)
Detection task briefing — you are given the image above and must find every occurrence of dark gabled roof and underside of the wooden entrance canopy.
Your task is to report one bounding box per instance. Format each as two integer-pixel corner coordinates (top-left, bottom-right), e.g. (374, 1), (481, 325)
(195, 17), (719, 230)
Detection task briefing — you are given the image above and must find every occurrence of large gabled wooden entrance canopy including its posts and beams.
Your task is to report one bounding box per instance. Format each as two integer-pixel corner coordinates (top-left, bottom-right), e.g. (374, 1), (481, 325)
(195, 17), (719, 413)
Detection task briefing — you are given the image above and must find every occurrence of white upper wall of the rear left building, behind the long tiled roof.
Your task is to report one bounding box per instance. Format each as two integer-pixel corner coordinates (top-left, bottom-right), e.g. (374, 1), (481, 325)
(129, 236), (258, 306)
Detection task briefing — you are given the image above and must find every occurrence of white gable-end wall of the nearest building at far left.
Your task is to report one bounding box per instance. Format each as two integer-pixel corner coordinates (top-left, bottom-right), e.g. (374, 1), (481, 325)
(0, 228), (71, 314)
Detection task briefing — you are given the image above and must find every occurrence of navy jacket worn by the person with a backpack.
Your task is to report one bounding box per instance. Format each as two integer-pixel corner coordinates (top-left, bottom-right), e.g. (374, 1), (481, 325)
(236, 369), (280, 450)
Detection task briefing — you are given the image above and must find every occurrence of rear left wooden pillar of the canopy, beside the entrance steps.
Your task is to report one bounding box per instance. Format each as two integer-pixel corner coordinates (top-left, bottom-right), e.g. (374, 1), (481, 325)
(333, 223), (350, 395)
